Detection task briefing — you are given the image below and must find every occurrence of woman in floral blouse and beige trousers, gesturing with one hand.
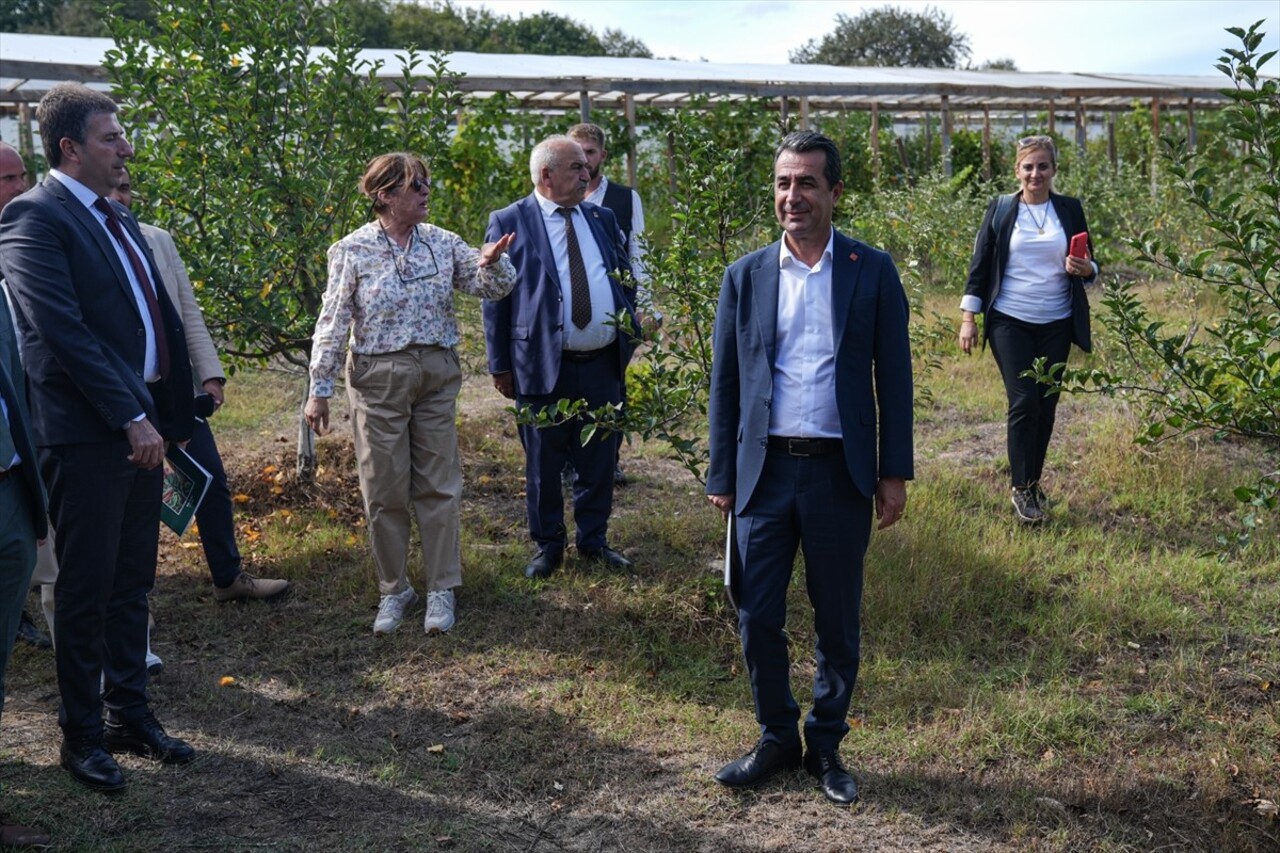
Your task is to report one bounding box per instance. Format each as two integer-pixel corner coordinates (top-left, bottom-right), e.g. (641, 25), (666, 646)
(305, 152), (516, 634)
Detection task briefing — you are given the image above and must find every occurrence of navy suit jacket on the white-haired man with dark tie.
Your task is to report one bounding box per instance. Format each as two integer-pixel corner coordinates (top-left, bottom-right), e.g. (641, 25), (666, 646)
(484, 193), (640, 397)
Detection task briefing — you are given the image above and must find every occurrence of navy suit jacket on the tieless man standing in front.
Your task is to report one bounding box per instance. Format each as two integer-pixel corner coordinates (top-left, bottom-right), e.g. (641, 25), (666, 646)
(707, 232), (915, 512)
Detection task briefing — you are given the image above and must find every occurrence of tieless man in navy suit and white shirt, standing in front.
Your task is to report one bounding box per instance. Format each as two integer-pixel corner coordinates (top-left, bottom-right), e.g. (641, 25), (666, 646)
(707, 131), (913, 806)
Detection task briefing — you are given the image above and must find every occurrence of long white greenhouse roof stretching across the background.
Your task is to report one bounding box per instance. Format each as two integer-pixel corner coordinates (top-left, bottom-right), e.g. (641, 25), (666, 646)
(0, 33), (1249, 110)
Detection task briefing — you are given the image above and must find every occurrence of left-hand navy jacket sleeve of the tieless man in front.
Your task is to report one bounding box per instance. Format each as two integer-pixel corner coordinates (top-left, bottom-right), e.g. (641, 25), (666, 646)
(707, 266), (745, 494)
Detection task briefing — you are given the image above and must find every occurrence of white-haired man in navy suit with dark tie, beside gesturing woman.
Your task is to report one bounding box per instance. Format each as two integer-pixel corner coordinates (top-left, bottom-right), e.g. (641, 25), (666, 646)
(484, 136), (639, 579)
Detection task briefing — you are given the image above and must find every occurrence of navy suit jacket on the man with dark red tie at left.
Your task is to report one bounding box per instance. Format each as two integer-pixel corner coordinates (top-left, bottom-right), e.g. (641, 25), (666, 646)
(0, 177), (193, 447)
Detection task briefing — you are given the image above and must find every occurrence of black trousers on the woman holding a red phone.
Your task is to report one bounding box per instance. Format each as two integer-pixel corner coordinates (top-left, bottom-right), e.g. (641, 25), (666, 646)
(987, 310), (1071, 488)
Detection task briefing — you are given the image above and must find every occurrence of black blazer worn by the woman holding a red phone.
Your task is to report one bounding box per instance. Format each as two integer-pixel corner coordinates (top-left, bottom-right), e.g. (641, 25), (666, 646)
(964, 192), (1097, 352)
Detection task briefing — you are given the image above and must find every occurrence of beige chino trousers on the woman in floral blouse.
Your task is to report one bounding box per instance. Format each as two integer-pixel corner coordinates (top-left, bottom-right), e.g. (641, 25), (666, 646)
(347, 346), (462, 596)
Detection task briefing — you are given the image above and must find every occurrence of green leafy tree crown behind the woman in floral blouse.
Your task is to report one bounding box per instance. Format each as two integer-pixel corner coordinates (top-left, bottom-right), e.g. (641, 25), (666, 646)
(106, 0), (454, 365)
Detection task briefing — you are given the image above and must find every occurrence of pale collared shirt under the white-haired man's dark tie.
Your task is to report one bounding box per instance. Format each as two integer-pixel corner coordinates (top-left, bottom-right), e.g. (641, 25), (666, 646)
(534, 192), (618, 352)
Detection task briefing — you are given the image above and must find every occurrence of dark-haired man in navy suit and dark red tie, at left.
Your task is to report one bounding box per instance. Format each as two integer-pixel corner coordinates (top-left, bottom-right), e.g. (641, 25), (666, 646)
(0, 83), (195, 792)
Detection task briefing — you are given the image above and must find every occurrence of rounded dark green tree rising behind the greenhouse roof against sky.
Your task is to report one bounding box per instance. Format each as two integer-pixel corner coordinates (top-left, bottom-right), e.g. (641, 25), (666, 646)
(791, 6), (972, 68)
